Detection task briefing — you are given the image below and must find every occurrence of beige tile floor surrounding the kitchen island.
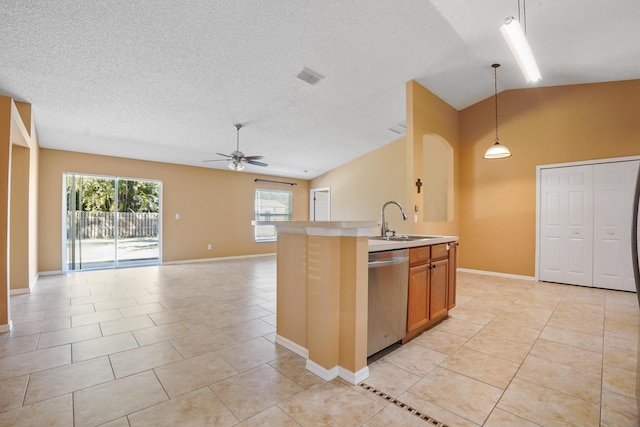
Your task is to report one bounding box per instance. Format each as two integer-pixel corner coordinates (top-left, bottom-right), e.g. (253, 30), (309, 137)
(0, 256), (640, 427)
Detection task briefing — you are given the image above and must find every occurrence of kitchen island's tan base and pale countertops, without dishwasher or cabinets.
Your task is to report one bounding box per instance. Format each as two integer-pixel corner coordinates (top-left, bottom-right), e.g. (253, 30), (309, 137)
(262, 221), (457, 384)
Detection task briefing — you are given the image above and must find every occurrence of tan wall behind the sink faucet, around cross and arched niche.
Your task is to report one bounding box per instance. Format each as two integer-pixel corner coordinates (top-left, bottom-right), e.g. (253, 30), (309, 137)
(311, 81), (460, 239)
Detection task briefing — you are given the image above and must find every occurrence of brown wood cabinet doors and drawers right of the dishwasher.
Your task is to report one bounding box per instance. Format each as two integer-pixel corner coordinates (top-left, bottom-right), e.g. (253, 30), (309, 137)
(403, 242), (456, 342)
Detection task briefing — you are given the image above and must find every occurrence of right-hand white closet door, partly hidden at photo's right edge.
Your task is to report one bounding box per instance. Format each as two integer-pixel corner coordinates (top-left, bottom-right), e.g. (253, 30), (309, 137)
(593, 160), (640, 291)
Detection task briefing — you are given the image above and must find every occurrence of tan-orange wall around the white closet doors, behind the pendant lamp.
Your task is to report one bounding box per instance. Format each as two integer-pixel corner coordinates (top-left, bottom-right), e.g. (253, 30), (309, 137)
(459, 80), (640, 276)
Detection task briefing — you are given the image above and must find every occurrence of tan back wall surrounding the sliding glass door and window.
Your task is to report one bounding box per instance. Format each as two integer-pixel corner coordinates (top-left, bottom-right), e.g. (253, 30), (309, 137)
(38, 149), (309, 272)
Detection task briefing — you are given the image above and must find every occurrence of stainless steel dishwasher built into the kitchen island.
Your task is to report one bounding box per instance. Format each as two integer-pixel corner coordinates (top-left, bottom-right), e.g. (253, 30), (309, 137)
(367, 249), (409, 357)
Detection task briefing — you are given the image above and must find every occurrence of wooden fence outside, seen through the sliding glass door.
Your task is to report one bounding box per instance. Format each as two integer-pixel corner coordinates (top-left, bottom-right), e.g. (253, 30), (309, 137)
(67, 211), (159, 239)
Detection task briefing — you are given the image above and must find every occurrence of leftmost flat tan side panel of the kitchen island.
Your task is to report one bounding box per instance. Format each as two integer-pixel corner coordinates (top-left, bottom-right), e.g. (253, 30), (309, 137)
(276, 232), (307, 349)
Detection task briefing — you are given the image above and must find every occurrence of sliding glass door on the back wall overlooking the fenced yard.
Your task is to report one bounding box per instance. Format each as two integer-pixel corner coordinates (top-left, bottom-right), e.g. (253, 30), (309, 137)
(63, 173), (161, 271)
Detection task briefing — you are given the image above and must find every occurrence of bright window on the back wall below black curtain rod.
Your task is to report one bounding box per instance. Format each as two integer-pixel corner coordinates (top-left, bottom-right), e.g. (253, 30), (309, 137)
(254, 189), (291, 242)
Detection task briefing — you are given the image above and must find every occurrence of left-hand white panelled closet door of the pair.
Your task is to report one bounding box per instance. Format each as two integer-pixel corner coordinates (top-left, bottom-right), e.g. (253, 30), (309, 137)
(539, 165), (593, 286)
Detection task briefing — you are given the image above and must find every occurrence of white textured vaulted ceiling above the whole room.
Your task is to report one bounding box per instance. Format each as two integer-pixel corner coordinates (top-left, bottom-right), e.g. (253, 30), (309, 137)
(0, 0), (640, 179)
